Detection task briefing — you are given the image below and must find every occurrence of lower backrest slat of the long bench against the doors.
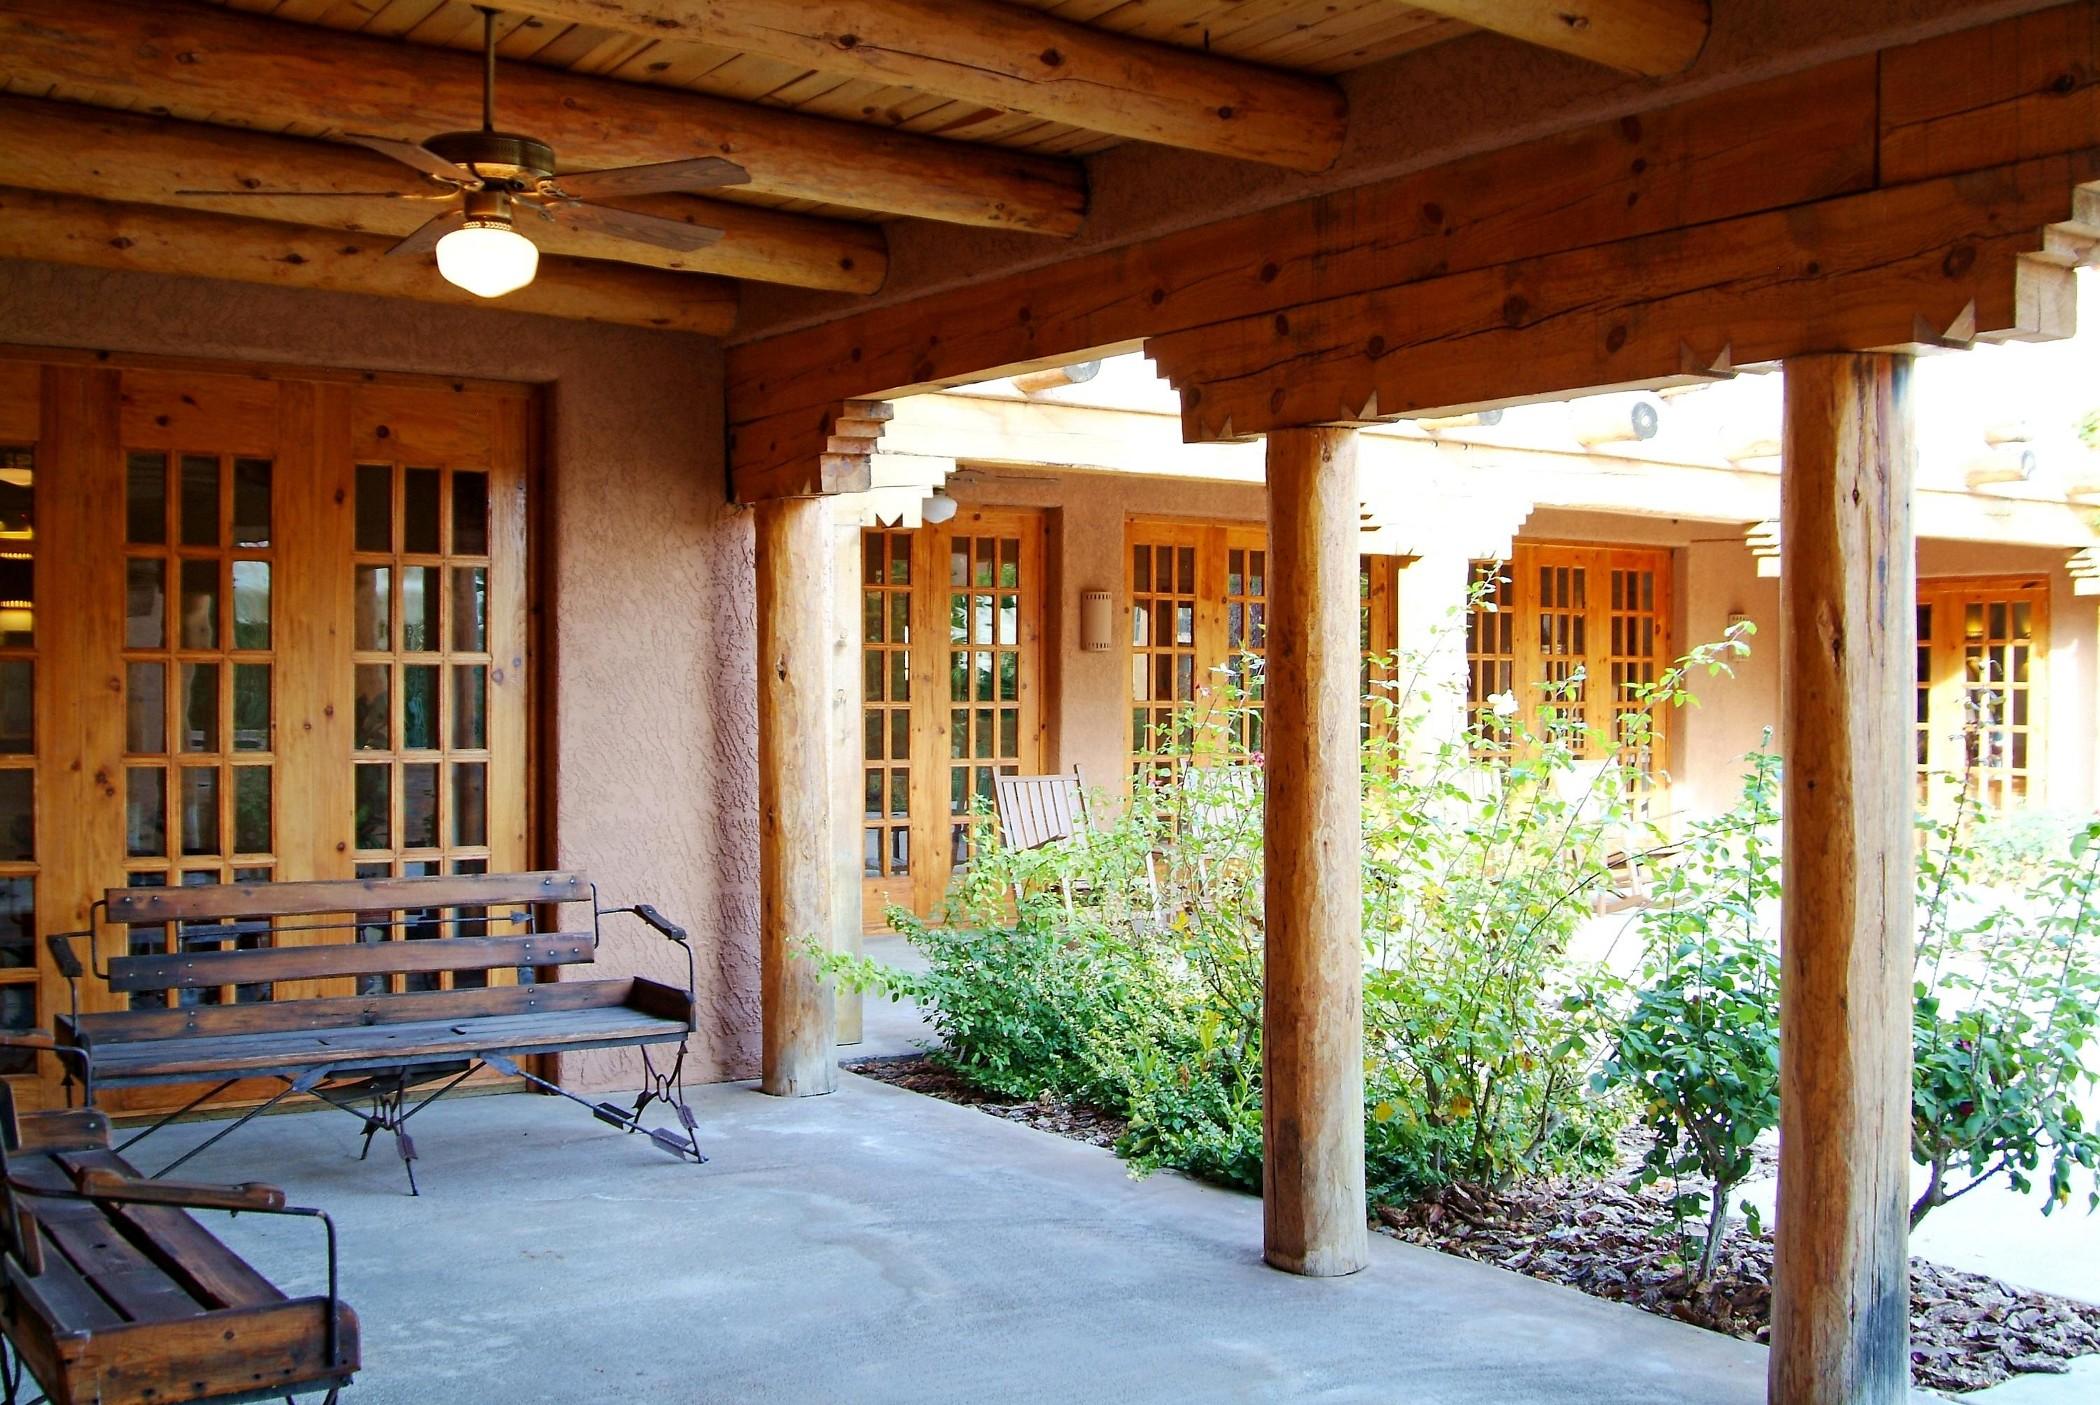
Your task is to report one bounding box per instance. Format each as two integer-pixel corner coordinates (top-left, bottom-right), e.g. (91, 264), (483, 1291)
(109, 932), (596, 991)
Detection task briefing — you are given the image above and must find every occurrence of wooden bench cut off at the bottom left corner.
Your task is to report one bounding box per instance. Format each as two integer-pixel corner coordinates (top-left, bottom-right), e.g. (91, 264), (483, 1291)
(0, 1035), (359, 1405)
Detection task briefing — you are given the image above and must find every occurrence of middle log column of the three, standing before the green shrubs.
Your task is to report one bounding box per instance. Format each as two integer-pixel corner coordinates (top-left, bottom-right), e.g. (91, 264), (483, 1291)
(1262, 428), (1369, 1277)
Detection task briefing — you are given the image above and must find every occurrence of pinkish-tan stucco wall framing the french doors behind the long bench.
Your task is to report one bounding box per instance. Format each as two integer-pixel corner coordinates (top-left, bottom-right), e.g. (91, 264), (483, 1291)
(0, 260), (758, 1088)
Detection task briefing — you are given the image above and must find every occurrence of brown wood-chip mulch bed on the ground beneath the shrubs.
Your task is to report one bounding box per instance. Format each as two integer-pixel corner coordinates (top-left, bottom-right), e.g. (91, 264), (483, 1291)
(840, 1054), (2100, 1392)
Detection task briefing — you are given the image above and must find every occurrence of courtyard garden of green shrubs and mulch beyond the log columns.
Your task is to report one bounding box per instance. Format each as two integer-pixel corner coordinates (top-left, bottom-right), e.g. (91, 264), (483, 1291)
(825, 601), (2100, 1390)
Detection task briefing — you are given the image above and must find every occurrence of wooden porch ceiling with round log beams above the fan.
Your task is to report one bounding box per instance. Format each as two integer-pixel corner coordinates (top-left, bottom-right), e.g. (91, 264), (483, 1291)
(0, 0), (1707, 332)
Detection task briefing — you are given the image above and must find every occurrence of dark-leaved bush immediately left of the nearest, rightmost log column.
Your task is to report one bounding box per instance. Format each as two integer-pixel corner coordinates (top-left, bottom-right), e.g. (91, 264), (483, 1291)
(1600, 733), (1779, 1283)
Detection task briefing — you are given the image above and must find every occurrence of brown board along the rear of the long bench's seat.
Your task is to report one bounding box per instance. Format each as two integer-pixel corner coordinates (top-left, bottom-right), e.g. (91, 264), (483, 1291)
(71, 979), (638, 1054)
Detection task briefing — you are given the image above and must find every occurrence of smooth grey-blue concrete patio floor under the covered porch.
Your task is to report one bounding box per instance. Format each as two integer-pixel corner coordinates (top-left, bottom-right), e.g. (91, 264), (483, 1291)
(139, 1075), (1764, 1405)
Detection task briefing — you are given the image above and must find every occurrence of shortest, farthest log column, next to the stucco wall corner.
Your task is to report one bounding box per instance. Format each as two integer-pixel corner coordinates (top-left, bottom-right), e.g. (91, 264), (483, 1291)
(754, 498), (840, 1098)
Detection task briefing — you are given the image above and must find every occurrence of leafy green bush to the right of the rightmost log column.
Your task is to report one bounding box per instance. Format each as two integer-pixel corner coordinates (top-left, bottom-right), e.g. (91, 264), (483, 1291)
(1911, 785), (2100, 1229)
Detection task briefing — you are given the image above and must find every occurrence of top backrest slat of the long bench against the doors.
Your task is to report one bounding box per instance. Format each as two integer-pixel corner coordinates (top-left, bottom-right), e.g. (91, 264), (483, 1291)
(103, 872), (590, 926)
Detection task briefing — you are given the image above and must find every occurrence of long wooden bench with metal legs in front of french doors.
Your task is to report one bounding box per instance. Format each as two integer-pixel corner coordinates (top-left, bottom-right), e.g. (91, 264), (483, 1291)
(50, 874), (706, 1193)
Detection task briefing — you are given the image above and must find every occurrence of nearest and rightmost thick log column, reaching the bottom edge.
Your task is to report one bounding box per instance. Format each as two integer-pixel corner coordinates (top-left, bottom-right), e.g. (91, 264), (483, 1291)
(1768, 355), (1917, 1405)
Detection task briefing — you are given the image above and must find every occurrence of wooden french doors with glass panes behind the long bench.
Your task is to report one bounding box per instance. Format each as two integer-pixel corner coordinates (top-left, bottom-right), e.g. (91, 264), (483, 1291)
(0, 351), (531, 1100)
